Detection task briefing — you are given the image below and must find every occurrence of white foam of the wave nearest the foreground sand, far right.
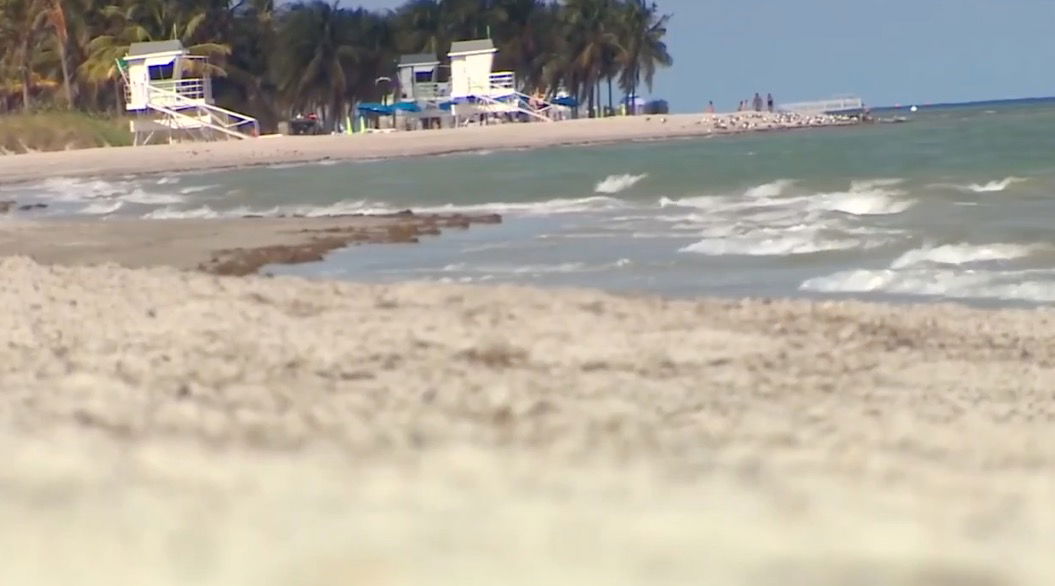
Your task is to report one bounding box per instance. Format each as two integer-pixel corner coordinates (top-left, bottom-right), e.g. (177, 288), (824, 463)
(799, 269), (1055, 302)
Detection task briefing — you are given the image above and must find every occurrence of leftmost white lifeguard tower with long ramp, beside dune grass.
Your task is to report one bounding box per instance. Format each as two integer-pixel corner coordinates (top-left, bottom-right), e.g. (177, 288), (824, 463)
(117, 40), (260, 145)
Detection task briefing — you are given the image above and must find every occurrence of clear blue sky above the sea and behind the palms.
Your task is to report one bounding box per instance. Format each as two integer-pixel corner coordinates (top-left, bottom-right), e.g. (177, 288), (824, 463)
(342, 0), (1055, 111)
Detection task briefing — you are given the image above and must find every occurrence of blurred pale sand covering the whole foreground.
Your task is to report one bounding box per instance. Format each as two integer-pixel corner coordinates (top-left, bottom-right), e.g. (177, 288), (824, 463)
(0, 258), (1055, 586)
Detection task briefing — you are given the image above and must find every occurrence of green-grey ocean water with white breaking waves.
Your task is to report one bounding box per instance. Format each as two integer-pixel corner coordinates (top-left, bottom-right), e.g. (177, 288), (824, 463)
(6, 102), (1055, 305)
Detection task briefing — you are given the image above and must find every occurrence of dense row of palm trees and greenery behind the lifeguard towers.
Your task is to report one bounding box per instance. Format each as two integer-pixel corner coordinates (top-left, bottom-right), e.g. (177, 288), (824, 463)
(0, 0), (672, 130)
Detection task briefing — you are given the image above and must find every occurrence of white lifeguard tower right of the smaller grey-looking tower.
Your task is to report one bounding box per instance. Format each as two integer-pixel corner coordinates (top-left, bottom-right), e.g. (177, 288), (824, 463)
(447, 39), (553, 122)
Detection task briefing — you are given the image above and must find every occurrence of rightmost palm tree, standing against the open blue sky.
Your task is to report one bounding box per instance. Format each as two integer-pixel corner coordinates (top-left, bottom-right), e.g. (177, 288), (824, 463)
(619, 0), (674, 112)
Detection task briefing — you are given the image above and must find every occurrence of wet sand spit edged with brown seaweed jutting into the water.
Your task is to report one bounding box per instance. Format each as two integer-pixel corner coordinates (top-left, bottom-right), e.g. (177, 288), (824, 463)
(0, 210), (502, 277)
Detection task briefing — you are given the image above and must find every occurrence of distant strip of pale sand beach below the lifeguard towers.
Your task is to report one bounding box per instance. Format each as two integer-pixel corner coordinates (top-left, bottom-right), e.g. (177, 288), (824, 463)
(0, 112), (860, 185)
